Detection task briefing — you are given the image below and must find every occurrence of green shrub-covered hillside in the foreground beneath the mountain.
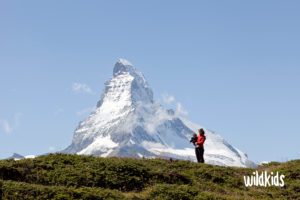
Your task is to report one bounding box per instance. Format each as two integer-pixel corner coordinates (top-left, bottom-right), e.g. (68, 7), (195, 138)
(0, 154), (300, 200)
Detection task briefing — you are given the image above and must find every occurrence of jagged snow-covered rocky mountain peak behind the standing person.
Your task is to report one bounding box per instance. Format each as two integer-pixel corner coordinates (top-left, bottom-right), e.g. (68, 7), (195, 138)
(63, 59), (254, 167)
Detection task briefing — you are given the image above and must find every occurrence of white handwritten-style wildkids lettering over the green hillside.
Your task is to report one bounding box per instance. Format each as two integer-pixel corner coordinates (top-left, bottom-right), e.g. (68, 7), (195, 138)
(244, 171), (285, 187)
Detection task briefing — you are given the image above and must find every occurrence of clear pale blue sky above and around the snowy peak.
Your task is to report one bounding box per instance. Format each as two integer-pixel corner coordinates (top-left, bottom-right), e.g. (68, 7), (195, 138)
(0, 0), (300, 161)
